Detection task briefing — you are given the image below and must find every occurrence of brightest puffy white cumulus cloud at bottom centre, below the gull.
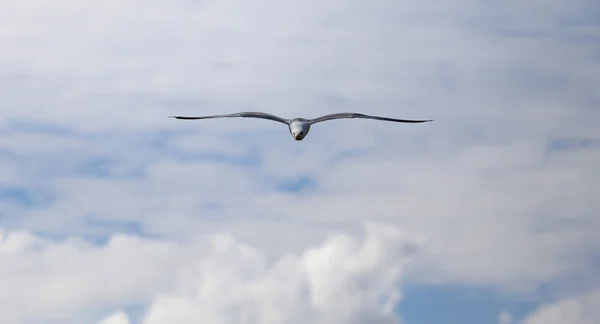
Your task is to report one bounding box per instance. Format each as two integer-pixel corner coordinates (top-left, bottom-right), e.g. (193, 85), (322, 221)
(144, 225), (414, 324)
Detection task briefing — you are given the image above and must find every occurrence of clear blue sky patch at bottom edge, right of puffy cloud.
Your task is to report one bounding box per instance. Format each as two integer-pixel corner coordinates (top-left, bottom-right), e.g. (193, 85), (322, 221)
(397, 286), (539, 324)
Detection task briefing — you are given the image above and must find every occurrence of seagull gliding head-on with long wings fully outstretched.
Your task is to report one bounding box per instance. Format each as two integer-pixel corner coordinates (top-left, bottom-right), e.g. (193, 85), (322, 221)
(169, 111), (433, 141)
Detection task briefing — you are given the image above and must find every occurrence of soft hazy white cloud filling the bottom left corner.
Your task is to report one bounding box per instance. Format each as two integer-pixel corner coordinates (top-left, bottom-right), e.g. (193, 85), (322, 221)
(0, 231), (181, 323)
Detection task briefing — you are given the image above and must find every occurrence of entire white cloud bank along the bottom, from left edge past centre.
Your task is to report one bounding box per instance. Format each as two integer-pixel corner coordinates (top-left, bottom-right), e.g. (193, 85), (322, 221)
(0, 224), (422, 324)
